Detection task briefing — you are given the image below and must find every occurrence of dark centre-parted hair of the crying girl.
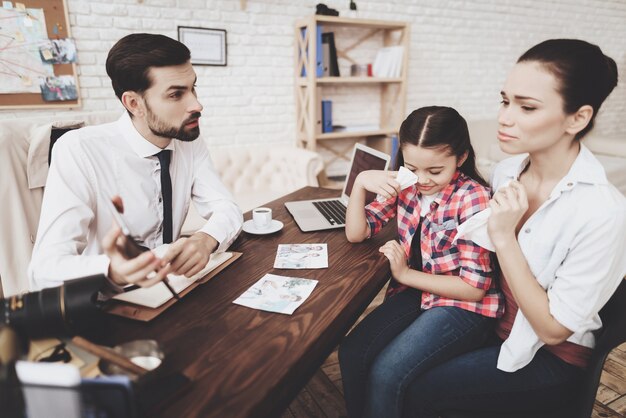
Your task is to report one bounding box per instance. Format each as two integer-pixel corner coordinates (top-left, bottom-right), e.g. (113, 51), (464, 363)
(396, 106), (487, 186)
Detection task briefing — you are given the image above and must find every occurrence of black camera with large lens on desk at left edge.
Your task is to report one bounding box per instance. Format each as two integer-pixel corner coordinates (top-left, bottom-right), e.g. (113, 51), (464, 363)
(0, 274), (106, 338)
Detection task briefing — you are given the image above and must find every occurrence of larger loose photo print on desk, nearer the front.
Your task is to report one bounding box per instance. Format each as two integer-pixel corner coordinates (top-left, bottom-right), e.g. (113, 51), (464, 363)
(233, 274), (317, 315)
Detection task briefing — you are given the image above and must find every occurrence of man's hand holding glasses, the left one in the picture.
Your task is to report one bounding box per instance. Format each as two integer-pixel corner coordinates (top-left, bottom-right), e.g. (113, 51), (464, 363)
(102, 226), (170, 287)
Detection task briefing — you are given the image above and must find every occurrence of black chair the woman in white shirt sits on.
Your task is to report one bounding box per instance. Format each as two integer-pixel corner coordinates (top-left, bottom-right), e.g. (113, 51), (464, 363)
(441, 278), (626, 418)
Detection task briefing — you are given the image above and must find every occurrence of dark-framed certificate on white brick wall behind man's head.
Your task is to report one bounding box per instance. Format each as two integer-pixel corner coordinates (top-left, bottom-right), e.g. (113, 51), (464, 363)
(178, 26), (226, 66)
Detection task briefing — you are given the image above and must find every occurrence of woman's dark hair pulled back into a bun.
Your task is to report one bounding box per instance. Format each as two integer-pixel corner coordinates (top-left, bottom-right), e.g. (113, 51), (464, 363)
(517, 39), (617, 139)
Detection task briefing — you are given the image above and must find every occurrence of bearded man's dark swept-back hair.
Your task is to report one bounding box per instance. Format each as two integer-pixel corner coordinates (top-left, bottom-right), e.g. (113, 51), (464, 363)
(106, 33), (191, 100)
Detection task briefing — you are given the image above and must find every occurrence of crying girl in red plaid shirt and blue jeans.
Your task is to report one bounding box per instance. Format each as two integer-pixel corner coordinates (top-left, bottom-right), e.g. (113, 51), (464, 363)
(339, 106), (503, 417)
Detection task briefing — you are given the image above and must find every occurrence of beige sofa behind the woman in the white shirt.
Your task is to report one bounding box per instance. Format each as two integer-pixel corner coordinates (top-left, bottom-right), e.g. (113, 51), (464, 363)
(468, 120), (626, 195)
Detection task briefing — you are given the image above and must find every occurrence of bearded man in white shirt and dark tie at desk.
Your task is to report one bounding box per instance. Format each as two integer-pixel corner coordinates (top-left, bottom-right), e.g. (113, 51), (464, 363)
(29, 33), (243, 290)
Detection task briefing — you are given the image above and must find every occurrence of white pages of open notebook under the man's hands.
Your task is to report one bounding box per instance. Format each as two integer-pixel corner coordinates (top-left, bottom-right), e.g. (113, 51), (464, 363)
(113, 244), (233, 308)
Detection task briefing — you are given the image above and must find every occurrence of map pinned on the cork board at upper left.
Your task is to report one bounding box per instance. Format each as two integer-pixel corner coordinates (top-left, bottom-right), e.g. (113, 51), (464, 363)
(0, 2), (54, 94)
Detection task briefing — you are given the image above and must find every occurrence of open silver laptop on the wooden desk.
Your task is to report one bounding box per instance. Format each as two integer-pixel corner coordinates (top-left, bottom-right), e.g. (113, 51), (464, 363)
(285, 143), (391, 232)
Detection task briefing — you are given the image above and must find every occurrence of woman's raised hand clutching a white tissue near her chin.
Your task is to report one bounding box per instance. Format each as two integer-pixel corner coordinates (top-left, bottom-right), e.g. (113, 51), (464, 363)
(487, 181), (528, 248)
